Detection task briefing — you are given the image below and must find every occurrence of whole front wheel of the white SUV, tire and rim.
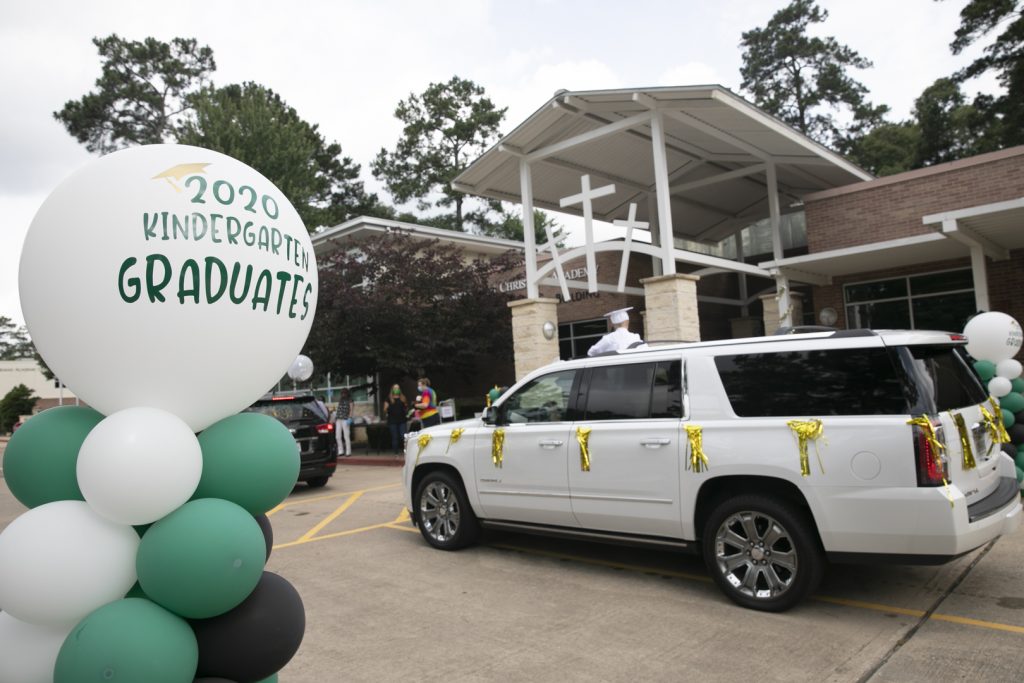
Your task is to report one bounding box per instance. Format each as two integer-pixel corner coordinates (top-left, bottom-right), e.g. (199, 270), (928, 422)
(416, 470), (480, 550)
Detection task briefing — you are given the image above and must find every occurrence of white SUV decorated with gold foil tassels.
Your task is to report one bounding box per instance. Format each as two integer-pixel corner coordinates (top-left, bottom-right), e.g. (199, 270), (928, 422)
(404, 330), (1021, 611)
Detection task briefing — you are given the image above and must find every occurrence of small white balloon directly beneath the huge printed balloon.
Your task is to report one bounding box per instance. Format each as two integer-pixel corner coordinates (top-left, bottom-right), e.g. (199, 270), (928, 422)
(77, 408), (203, 524)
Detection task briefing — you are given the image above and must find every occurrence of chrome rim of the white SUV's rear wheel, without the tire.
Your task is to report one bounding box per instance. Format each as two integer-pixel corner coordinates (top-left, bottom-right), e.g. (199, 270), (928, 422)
(715, 511), (798, 600)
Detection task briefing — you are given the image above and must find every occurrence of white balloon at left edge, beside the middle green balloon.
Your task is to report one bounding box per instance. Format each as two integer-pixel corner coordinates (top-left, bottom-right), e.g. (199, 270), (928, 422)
(0, 501), (139, 626)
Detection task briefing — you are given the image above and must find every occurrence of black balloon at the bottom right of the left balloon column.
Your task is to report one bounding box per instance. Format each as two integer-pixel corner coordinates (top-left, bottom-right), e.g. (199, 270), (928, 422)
(189, 571), (306, 681)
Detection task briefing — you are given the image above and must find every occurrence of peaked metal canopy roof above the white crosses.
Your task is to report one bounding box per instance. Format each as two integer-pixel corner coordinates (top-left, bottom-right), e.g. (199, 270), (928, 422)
(453, 85), (872, 243)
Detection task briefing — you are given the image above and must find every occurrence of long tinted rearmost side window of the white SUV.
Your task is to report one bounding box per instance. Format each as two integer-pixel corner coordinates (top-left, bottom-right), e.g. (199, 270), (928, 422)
(715, 348), (908, 417)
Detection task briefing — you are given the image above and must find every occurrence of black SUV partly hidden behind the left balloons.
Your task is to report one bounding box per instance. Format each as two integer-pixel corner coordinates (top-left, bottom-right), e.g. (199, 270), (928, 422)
(246, 392), (338, 488)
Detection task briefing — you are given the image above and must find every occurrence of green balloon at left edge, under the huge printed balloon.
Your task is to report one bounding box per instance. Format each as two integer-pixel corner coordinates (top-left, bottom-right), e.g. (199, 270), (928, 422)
(3, 405), (103, 508)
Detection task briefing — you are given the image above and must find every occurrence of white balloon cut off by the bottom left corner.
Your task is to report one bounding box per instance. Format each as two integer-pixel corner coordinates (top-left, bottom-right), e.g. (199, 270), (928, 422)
(0, 612), (75, 683)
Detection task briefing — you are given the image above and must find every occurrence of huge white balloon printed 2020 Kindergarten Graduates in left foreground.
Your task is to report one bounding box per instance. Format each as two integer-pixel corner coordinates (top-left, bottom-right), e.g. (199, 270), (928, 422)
(18, 144), (317, 431)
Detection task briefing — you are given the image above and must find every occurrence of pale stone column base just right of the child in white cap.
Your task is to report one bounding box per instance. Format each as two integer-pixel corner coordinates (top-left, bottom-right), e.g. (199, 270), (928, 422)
(640, 273), (700, 341)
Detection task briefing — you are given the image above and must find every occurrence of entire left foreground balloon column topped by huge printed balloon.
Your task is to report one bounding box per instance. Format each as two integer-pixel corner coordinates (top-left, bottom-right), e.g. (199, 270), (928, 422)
(0, 145), (317, 683)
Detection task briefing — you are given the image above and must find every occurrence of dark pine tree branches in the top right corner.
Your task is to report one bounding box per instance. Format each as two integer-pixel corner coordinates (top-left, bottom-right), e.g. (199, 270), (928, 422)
(949, 0), (1024, 146)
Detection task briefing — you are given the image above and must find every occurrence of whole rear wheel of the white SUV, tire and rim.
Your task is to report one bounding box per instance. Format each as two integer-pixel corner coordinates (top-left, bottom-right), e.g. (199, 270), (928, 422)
(701, 495), (825, 611)
